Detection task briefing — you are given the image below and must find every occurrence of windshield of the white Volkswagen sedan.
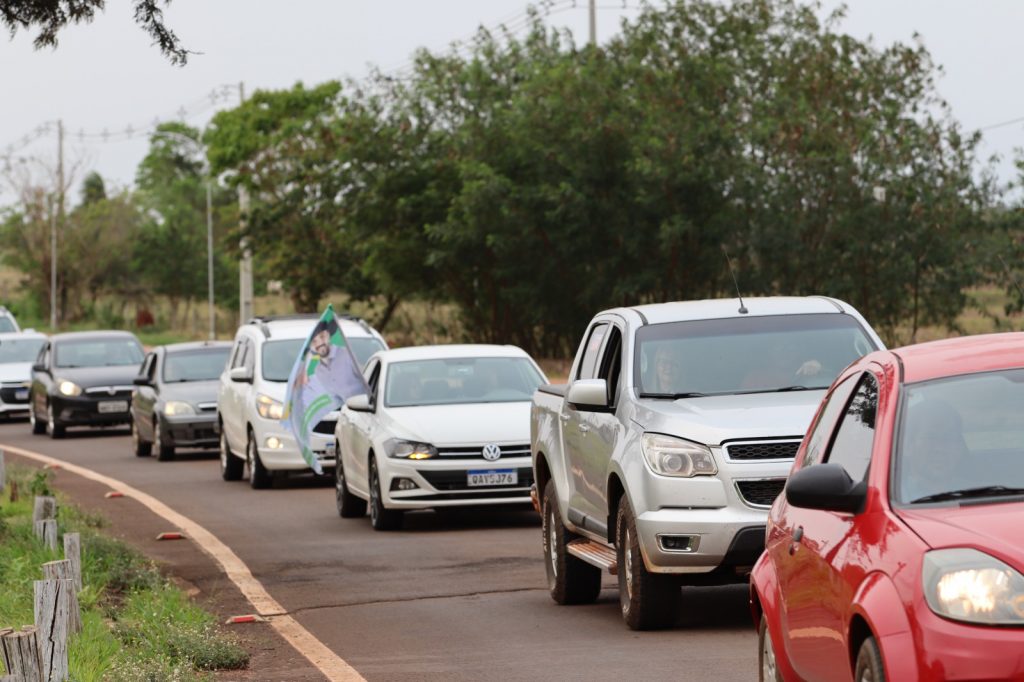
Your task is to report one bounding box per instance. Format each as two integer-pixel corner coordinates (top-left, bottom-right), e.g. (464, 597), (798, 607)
(384, 357), (544, 408)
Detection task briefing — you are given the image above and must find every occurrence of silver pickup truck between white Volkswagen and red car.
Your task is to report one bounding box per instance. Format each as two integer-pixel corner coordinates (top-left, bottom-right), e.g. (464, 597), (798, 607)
(530, 297), (883, 630)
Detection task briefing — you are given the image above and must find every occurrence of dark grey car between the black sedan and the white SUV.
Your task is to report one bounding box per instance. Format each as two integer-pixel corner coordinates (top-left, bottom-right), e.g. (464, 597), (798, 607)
(131, 341), (231, 461)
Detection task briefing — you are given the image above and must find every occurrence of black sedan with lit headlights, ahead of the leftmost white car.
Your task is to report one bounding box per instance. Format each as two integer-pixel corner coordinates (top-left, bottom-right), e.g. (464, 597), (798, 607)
(29, 332), (143, 438)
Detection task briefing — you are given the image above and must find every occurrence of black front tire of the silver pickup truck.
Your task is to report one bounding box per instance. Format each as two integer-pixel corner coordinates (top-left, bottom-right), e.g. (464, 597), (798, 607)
(615, 495), (682, 630)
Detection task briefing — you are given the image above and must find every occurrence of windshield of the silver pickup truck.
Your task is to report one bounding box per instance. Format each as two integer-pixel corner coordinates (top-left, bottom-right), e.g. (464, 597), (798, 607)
(633, 313), (877, 397)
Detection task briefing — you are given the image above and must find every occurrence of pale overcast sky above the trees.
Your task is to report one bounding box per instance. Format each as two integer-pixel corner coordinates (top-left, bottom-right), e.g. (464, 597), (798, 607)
(0, 0), (1024, 204)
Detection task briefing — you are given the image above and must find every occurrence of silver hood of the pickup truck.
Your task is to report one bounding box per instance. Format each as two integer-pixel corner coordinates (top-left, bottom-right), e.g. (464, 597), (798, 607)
(633, 389), (825, 445)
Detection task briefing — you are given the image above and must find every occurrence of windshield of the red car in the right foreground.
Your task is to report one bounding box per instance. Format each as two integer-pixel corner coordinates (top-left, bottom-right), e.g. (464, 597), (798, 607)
(891, 370), (1024, 504)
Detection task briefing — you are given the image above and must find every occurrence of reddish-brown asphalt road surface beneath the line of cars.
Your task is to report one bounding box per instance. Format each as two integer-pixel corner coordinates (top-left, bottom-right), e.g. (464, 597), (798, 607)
(0, 423), (757, 681)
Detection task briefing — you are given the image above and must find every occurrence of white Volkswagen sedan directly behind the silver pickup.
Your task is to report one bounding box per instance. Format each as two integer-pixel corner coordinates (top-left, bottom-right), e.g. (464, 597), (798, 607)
(335, 345), (547, 530)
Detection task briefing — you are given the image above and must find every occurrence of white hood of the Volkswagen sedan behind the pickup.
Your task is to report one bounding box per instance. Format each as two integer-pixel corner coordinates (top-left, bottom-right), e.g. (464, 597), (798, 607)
(387, 402), (530, 445)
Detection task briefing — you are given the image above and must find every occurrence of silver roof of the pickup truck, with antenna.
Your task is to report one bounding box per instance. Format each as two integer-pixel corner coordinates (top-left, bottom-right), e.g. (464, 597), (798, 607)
(605, 296), (846, 325)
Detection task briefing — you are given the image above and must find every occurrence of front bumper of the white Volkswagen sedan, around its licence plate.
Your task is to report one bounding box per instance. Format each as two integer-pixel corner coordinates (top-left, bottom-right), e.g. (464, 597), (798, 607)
(379, 457), (534, 509)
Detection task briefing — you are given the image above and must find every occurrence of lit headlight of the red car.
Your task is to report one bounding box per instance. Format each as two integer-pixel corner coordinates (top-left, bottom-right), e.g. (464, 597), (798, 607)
(922, 549), (1024, 626)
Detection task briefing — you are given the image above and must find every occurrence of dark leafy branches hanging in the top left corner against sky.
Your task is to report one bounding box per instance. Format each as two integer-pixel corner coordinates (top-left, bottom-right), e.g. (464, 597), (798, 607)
(0, 0), (189, 66)
